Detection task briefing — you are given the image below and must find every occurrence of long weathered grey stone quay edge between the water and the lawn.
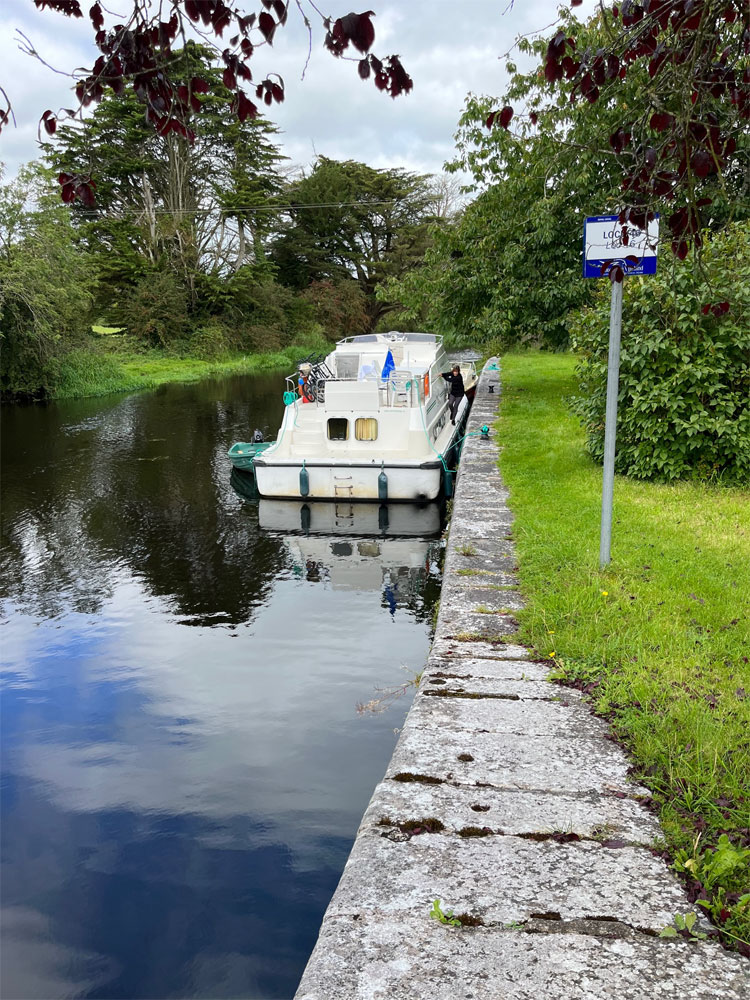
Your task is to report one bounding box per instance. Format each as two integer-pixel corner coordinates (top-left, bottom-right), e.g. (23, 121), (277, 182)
(296, 367), (750, 1000)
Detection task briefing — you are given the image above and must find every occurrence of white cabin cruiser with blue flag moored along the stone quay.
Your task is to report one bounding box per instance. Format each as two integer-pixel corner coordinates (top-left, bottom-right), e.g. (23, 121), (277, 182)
(250, 333), (476, 503)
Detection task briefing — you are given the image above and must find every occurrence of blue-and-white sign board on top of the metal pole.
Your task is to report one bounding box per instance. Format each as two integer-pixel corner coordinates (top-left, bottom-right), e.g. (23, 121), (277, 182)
(583, 215), (659, 278)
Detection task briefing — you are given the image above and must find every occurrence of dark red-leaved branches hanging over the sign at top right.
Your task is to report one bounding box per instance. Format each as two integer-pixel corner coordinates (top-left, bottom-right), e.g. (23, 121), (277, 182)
(486, 0), (750, 266)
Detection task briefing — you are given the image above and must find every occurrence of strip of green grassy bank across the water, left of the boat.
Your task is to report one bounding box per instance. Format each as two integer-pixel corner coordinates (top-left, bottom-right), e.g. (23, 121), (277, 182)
(52, 340), (331, 399)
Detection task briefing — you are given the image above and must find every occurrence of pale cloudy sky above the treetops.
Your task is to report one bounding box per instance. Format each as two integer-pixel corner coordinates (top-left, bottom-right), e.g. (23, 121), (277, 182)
(0, 0), (593, 176)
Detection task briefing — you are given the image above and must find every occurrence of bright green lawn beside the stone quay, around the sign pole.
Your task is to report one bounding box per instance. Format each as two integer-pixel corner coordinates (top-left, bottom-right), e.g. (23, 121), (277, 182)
(498, 354), (750, 955)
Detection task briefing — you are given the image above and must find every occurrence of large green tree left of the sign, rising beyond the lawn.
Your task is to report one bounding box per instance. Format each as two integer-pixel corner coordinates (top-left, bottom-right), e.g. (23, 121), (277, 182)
(384, 2), (750, 347)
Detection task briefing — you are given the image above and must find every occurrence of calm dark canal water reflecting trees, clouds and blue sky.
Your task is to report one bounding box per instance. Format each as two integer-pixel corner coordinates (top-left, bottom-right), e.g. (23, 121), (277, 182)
(0, 376), (440, 1000)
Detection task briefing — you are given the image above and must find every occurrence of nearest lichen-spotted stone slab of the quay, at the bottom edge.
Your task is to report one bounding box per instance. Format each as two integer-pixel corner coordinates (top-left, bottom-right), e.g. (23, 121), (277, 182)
(297, 914), (747, 1000)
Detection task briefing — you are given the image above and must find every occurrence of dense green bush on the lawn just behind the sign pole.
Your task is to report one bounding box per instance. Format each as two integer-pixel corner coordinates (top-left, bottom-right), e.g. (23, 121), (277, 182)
(571, 222), (750, 482)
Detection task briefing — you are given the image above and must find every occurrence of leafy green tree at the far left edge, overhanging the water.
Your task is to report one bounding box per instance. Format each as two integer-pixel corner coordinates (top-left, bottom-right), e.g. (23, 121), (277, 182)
(0, 164), (94, 396)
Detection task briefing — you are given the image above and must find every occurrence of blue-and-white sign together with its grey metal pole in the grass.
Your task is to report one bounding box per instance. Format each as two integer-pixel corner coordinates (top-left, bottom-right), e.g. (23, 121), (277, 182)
(583, 215), (659, 569)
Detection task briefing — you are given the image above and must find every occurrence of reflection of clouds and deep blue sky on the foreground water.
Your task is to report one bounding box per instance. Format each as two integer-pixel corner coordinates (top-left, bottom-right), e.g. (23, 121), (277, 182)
(2, 568), (434, 997)
